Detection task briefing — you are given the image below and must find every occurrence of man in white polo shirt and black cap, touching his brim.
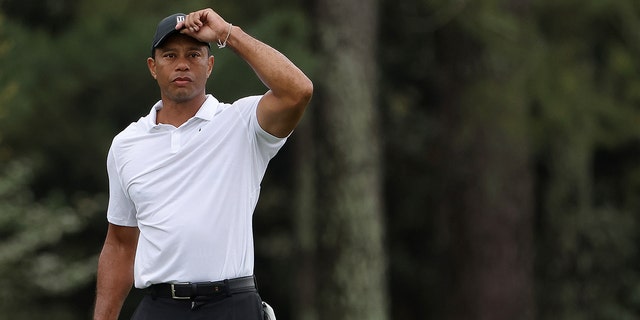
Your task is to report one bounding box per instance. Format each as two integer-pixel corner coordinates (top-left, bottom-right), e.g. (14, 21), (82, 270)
(94, 9), (313, 320)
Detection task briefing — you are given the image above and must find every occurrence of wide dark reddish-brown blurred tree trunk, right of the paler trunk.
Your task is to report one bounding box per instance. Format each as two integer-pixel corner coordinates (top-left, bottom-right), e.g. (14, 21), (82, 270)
(438, 1), (534, 320)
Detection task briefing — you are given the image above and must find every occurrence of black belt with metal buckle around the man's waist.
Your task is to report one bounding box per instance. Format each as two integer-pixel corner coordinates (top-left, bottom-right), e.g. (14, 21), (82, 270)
(147, 276), (258, 300)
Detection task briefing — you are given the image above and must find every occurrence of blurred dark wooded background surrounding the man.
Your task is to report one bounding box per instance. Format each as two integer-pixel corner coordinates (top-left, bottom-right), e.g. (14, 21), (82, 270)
(0, 0), (640, 320)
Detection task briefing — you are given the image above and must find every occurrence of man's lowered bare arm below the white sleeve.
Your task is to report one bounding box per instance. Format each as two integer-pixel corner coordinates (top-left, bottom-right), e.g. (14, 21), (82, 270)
(93, 224), (138, 320)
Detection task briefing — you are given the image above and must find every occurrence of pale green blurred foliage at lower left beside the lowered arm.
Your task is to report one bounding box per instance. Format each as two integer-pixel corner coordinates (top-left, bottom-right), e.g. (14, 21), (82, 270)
(0, 160), (105, 320)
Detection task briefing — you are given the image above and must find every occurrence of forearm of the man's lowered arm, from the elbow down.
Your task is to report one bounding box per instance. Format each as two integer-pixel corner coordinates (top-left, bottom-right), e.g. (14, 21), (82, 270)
(93, 244), (133, 320)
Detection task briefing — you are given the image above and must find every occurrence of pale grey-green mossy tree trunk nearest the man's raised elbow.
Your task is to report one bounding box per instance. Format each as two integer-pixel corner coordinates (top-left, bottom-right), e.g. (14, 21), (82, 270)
(309, 0), (387, 320)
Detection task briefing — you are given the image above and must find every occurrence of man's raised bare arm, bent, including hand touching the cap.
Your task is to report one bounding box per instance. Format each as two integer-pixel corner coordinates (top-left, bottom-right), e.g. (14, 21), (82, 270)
(176, 9), (313, 137)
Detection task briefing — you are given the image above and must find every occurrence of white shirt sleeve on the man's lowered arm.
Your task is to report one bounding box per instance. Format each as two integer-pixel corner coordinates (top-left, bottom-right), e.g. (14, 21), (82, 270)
(107, 146), (137, 227)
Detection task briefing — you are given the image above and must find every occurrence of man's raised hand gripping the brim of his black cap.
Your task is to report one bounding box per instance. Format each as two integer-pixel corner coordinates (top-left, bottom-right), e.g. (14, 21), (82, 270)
(176, 8), (230, 42)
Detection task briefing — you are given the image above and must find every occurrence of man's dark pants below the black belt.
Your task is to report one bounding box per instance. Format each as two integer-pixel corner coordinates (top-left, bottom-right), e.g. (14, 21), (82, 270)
(131, 292), (264, 320)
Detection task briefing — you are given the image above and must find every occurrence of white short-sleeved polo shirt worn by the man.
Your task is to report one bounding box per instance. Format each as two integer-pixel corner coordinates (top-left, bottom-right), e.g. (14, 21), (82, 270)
(107, 95), (286, 288)
